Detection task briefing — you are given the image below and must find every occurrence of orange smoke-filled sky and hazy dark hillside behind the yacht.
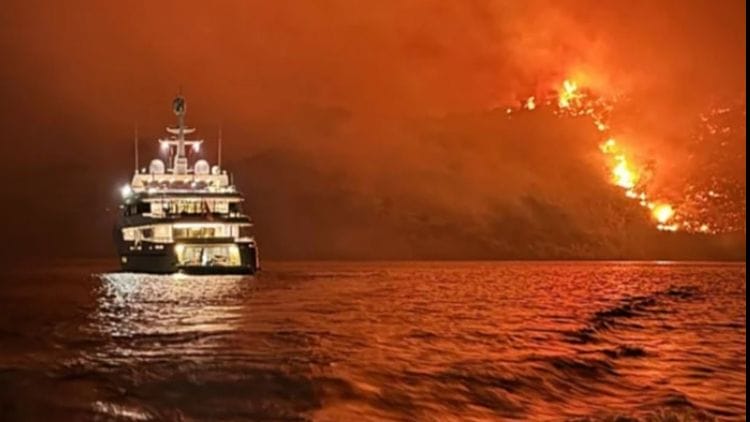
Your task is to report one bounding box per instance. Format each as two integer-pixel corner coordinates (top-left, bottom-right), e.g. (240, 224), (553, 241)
(0, 1), (746, 259)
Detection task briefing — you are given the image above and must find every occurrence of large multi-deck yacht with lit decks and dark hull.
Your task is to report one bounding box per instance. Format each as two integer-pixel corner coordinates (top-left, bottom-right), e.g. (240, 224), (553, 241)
(114, 95), (260, 274)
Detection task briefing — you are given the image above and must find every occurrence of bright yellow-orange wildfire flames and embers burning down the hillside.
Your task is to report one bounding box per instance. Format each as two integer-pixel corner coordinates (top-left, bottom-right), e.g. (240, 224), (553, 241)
(505, 79), (746, 234)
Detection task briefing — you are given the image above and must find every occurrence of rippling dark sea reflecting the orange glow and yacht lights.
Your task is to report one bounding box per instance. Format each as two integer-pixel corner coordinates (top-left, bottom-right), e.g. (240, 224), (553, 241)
(0, 263), (746, 421)
